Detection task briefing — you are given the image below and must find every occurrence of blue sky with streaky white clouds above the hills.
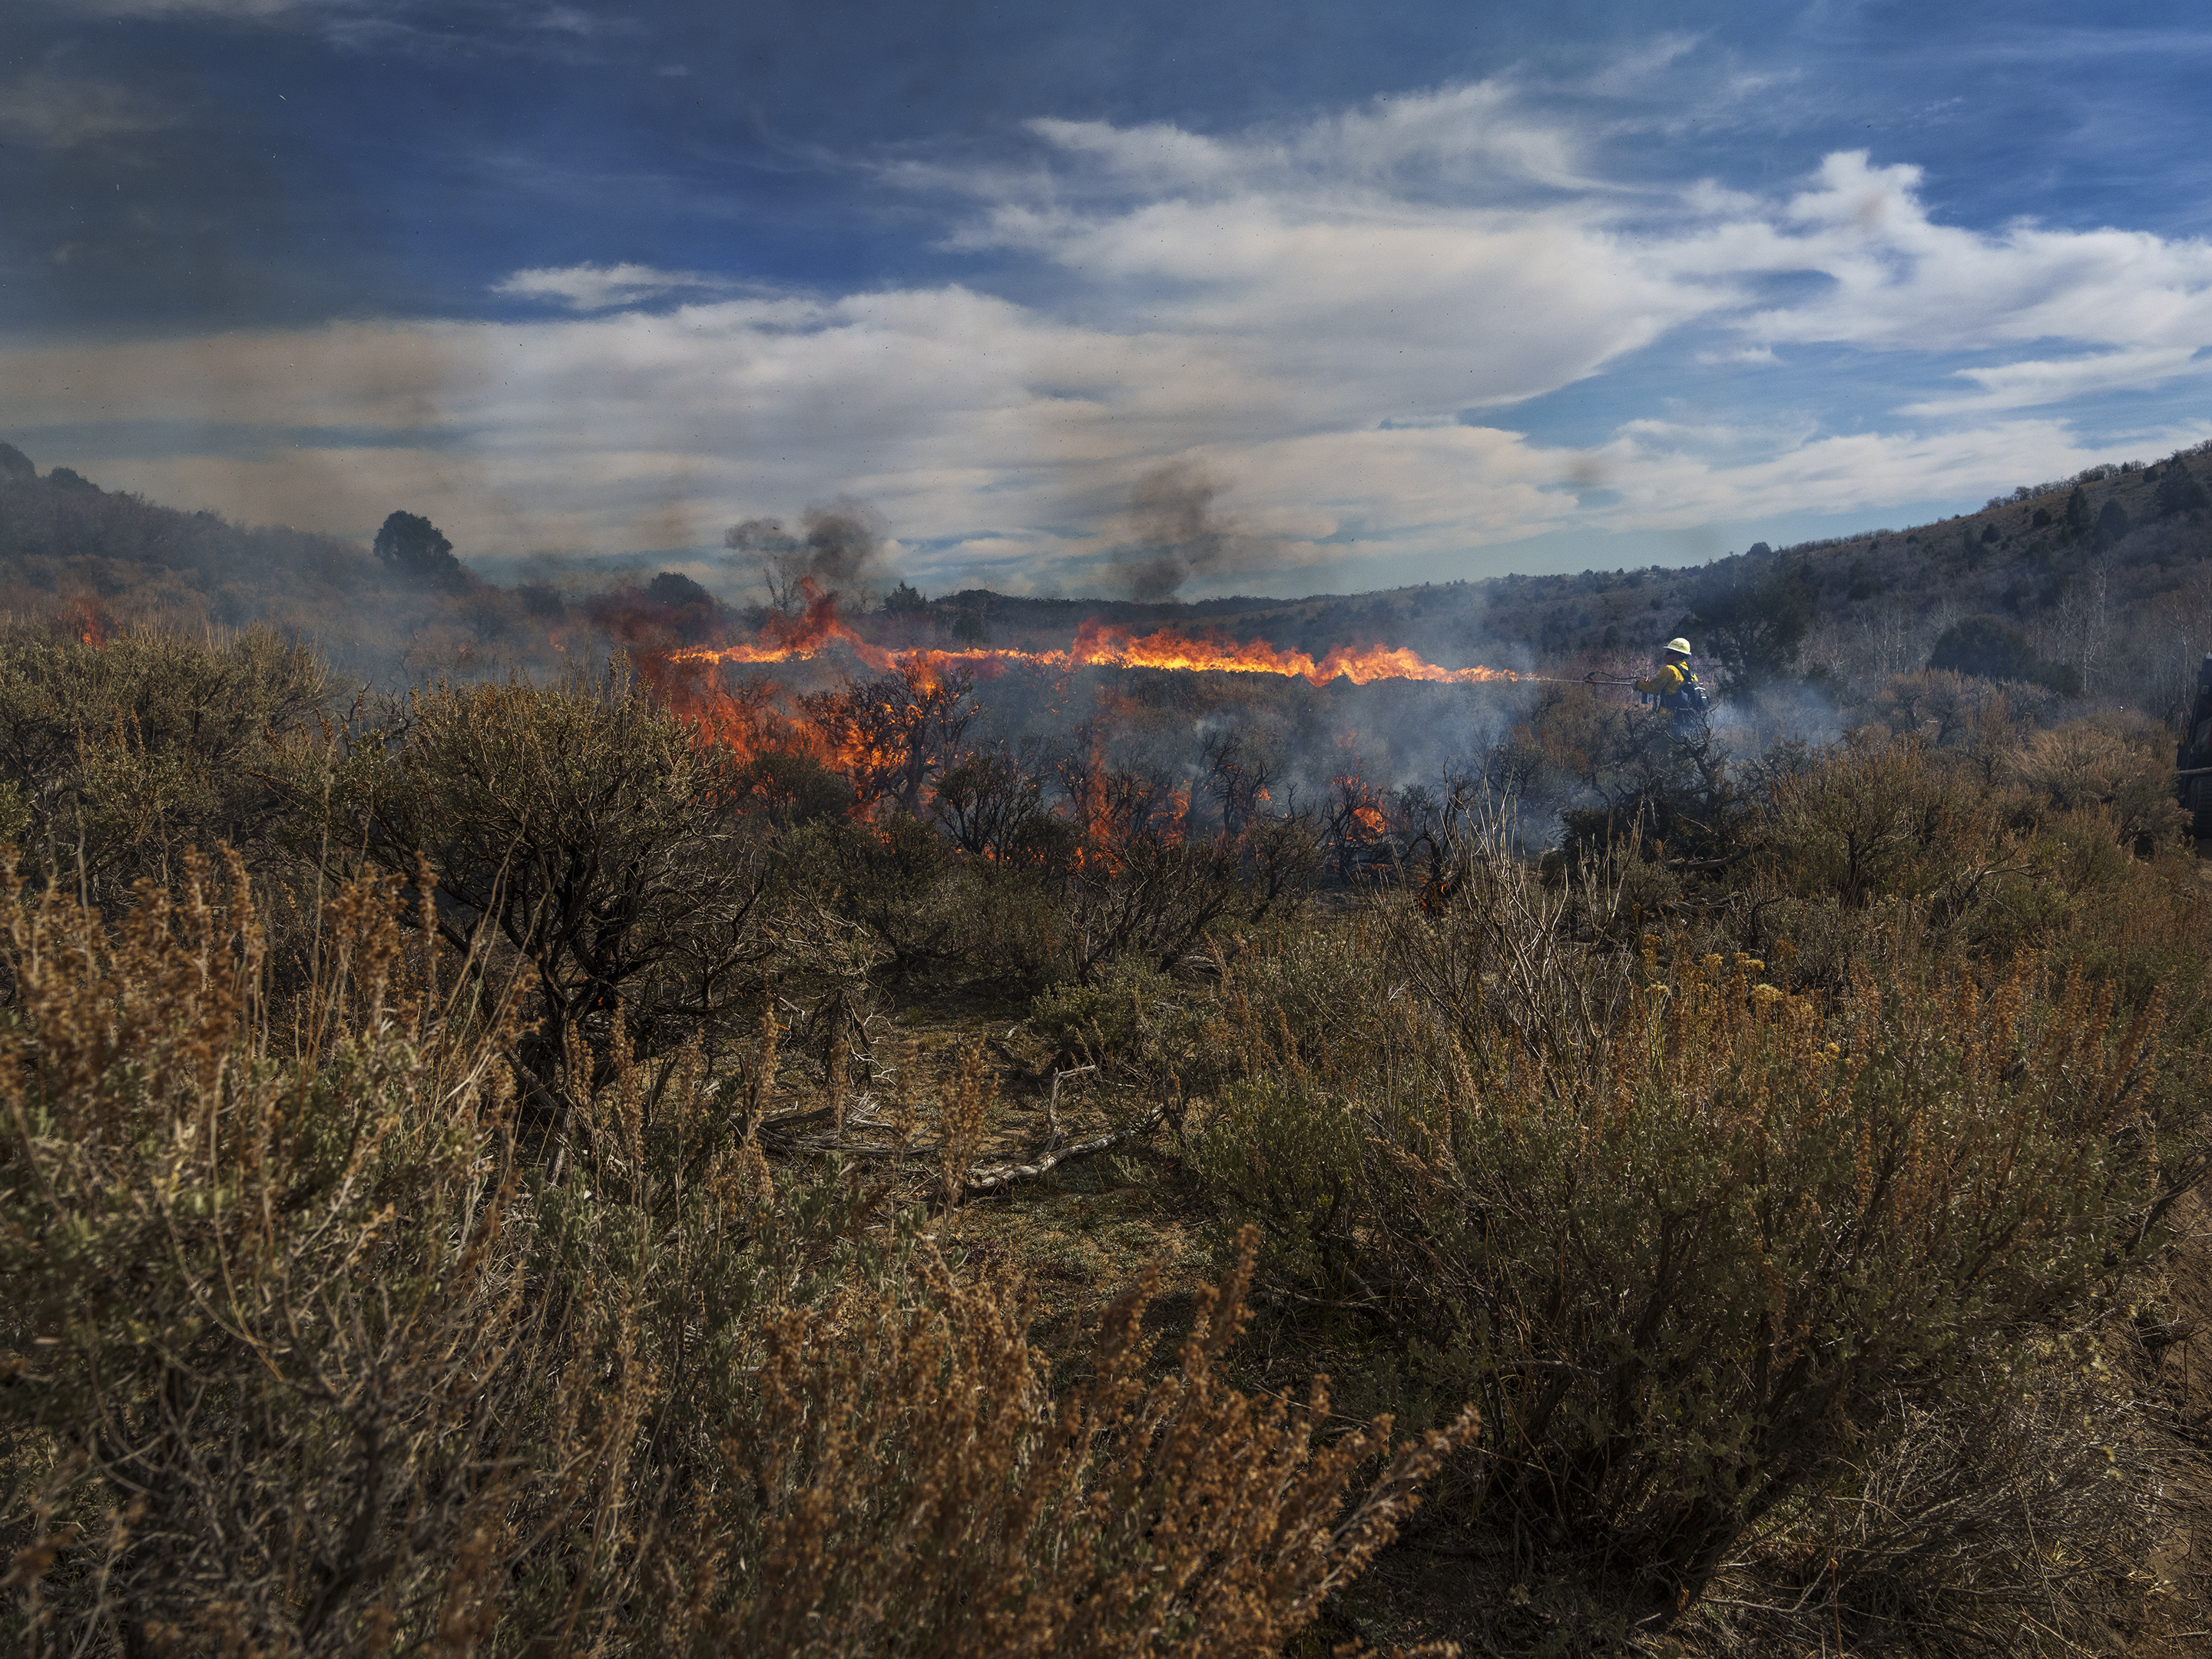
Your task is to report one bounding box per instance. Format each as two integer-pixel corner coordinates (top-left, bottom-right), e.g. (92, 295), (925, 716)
(0, 0), (2212, 598)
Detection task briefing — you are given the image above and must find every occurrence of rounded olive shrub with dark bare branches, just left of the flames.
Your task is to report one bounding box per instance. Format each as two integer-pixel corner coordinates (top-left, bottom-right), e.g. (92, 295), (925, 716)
(286, 666), (865, 1079)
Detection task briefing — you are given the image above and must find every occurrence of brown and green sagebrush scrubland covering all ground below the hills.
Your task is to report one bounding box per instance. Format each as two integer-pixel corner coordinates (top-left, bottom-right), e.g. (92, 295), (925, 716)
(0, 435), (2212, 1657)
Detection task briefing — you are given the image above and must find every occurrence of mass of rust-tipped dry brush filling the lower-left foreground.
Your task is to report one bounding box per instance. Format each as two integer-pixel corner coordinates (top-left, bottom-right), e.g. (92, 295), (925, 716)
(0, 865), (1471, 1659)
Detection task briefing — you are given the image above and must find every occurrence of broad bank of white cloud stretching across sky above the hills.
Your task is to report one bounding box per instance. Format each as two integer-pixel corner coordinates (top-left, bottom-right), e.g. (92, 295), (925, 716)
(12, 71), (2212, 586)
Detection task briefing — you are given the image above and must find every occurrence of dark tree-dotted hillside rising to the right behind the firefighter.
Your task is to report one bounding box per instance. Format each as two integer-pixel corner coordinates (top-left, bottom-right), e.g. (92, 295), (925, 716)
(893, 447), (2212, 719)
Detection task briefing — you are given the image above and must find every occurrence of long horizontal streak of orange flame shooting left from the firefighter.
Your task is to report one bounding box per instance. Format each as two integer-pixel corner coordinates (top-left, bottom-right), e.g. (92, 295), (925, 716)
(671, 591), (1524, 686)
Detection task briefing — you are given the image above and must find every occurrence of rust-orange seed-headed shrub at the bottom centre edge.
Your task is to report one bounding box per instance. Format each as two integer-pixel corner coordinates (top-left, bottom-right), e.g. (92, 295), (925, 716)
(701, 1239), (1473, 1659)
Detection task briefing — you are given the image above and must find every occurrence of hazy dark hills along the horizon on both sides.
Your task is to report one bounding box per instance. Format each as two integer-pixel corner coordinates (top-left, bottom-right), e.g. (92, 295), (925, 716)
(0, 445), (2212, 719)
